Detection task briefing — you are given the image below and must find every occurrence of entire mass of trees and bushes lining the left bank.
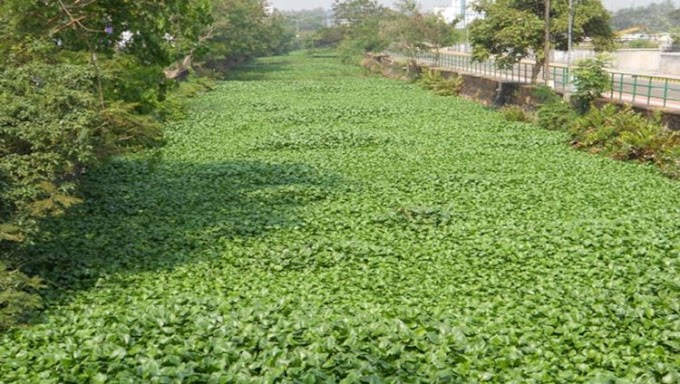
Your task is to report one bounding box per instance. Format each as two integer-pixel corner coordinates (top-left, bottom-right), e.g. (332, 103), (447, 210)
(0, 0), (292, 330)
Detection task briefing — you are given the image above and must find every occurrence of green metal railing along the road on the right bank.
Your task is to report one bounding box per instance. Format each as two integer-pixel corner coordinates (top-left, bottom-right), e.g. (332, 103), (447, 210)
(385, 51), (680, 109)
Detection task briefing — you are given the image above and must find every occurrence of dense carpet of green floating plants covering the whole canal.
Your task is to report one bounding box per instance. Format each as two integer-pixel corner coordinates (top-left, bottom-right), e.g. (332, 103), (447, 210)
(0, 55), (680, 383)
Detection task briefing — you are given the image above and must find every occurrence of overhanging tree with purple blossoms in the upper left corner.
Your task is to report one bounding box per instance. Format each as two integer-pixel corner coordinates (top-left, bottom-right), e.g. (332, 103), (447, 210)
(0, 0), (211, 109)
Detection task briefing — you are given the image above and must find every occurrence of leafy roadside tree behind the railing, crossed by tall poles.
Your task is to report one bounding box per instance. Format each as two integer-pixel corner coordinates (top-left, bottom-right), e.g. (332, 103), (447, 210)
(470, 0), (613, 82)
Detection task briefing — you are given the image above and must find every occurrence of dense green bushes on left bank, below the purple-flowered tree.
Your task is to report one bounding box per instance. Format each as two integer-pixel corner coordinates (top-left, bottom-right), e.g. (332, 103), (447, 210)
(0, 62), (162, 327)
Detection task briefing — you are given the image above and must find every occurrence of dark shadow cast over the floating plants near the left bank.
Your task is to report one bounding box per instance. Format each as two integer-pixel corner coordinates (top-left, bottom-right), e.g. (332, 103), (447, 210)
(17, 160), (338, 302)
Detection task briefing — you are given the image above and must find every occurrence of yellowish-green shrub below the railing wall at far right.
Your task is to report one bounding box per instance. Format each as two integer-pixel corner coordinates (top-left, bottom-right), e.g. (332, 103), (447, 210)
(571, 105), (680, 174)
